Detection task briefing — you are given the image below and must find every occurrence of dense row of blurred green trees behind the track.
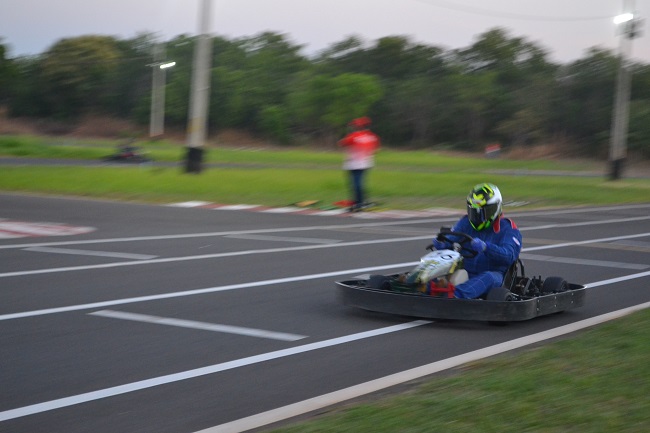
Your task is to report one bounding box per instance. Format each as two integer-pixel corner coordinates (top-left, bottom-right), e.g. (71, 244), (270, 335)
(0, 28), (650, 157)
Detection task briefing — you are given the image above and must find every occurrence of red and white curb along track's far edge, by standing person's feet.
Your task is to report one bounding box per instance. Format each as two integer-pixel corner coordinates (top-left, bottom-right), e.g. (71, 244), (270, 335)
(167, 201), (462, 219)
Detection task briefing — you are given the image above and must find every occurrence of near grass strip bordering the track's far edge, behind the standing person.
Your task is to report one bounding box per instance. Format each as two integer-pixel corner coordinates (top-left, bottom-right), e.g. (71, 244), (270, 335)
(0, 164), (650, 209)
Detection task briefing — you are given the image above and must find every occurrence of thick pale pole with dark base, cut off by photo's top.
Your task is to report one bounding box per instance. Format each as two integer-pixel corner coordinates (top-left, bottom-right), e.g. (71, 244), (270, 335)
(186, 0), (212, 173)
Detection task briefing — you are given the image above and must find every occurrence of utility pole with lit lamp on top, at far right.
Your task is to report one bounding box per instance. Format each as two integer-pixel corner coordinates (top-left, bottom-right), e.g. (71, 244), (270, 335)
(609, 0), (641, 180)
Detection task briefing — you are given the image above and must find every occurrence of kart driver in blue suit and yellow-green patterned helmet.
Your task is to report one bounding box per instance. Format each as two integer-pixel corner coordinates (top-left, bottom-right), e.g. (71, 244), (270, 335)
(433, 183), (522, 298)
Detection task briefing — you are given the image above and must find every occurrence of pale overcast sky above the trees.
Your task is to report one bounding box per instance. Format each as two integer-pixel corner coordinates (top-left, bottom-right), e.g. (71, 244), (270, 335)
(0, 0), (650, 63)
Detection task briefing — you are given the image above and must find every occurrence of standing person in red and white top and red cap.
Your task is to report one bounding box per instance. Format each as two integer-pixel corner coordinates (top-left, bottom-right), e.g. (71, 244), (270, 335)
(339, 117), (380, 212)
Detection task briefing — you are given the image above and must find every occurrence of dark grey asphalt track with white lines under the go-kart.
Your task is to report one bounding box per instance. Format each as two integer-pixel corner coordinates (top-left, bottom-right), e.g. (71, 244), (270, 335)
(0, 194), (650, 433)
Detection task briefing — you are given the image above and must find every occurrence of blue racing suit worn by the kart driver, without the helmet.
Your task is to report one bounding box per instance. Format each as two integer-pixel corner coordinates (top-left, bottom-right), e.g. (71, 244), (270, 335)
(436, 216), (522, 298)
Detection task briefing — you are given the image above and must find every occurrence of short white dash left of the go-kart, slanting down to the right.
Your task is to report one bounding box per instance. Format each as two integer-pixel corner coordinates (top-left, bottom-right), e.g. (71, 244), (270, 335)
(88, 310), (307, 341)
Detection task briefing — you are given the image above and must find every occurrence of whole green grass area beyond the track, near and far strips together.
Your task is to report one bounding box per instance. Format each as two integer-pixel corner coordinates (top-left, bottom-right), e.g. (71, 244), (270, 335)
(0, 137), (650, 209)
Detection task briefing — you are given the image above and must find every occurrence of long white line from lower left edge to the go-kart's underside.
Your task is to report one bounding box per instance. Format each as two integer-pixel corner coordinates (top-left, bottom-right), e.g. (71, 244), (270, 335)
(0, 320), (431, 422)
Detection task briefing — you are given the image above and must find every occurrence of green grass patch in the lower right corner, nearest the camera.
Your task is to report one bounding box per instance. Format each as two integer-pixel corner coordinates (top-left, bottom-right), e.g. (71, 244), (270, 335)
(273, 310), (650, 433)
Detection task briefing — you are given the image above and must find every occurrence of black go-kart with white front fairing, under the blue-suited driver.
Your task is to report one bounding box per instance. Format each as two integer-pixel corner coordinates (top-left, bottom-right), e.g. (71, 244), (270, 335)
(336, 227), (586, 323)
